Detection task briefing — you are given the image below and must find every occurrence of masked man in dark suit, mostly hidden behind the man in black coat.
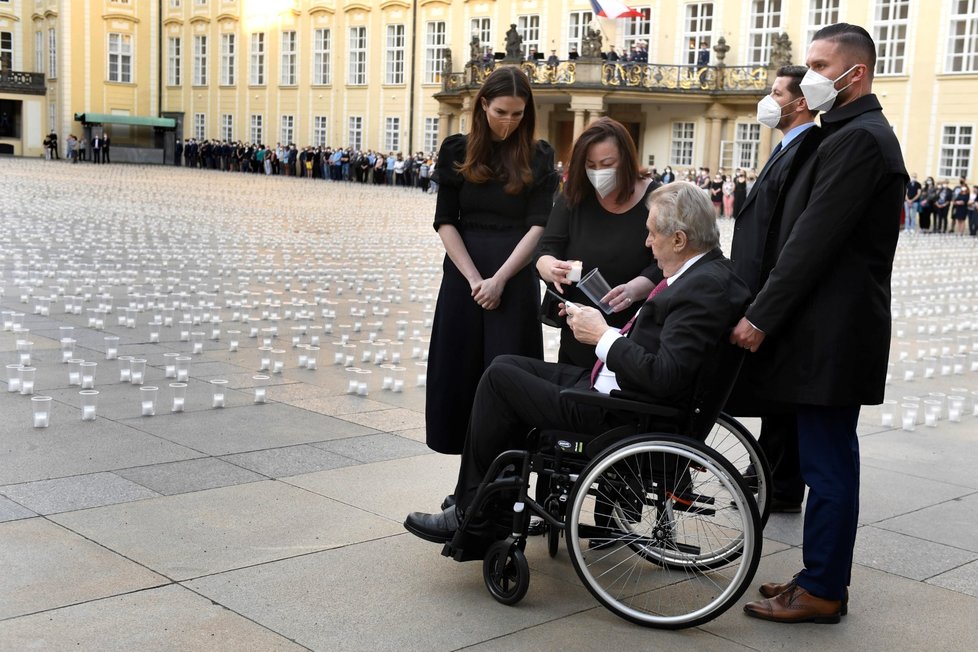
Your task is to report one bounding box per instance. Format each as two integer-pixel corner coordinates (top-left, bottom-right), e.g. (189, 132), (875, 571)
(726, 66), (819, 514)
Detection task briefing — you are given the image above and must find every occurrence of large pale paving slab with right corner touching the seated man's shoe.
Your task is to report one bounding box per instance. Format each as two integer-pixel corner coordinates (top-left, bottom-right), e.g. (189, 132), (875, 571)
(50, 481), (403, 580)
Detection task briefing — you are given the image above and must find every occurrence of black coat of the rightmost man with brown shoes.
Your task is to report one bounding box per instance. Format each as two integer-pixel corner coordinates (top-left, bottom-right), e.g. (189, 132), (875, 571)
(747, 95), (908, 405)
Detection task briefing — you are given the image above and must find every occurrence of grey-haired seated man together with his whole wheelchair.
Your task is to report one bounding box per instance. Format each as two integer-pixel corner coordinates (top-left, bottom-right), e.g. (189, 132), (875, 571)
(404, 182), (760, 628)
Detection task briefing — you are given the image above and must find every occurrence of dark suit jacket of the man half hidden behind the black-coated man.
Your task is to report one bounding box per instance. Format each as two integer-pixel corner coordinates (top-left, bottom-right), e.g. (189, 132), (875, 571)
(730, 127), (821, 295)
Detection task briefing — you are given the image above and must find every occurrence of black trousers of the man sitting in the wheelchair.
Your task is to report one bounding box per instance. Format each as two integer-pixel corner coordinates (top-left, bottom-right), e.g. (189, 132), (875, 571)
(455, 355), (615, 511)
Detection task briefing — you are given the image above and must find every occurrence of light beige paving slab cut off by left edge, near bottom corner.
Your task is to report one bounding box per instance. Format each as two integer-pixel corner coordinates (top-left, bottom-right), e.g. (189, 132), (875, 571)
(0, 518), (168, 620)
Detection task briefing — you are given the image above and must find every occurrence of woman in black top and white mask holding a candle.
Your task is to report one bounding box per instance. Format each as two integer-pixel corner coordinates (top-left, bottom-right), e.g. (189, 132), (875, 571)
(536, 118), (662, 367)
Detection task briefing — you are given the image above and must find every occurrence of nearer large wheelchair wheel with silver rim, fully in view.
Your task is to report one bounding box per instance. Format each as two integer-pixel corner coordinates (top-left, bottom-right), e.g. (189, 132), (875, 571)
(566, 434), (761, 629)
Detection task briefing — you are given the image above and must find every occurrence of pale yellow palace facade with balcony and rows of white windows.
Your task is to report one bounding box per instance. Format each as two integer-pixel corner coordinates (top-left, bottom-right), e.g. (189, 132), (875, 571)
(0, 0), (978, 177)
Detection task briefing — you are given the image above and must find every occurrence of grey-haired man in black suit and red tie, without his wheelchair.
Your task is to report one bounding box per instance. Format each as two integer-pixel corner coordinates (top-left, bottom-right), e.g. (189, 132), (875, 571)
(404, 181), (749, 542)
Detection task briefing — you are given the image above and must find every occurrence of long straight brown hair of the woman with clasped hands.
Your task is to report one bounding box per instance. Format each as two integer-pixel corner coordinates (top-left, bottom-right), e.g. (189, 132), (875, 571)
(459, 66), (537, 195)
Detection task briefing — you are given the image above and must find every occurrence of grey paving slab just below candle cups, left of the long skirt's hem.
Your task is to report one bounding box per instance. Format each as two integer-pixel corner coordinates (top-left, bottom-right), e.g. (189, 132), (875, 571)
(115, 403), (376, 456)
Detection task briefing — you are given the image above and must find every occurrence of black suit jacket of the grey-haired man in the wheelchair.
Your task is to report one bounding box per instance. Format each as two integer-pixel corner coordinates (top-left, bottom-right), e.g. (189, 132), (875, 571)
(607, 249), (750, 408)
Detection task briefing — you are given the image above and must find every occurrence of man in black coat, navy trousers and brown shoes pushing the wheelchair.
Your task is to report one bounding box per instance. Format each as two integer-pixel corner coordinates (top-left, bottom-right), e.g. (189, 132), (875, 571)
(731, 23), (909, 623)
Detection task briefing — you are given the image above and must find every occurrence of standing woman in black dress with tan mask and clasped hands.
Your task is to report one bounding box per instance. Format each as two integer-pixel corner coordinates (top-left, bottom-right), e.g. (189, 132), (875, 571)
(425, 67), (557, 454)
